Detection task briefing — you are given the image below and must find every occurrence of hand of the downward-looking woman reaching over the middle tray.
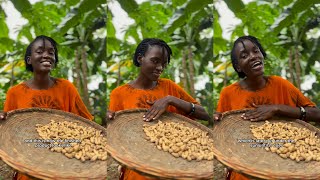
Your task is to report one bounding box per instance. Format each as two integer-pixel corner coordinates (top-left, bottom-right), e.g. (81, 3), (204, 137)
(143, 96), (173, 121)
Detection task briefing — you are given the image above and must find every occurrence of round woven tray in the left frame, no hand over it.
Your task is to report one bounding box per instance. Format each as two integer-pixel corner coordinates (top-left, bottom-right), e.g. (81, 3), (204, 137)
(0, 108), (107, 179)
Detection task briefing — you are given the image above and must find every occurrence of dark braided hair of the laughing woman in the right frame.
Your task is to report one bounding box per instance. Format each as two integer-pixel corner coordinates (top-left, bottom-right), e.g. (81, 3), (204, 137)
(231, 35), (267, 78)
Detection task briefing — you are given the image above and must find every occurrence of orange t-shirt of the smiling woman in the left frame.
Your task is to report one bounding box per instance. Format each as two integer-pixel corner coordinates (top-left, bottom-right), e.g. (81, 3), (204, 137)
(4, 78), (93, 180)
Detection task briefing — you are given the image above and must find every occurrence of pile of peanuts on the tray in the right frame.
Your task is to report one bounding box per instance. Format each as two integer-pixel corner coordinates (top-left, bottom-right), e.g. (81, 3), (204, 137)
(250, 121), (320, 162)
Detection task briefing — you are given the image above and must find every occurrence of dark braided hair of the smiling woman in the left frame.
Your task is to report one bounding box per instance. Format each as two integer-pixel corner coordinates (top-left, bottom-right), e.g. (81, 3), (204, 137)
(24, 35), (59, 72)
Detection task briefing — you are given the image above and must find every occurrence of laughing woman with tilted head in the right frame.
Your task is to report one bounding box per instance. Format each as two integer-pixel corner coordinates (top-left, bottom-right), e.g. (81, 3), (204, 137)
(214, 36), (320, 180)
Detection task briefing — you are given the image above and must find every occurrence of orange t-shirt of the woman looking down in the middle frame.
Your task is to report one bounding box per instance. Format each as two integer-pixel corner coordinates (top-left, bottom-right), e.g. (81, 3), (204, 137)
(109, 78), (199, 180)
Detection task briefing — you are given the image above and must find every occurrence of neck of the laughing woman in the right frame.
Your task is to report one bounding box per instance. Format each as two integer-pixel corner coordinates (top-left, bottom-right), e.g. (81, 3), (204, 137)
(240, 76), (267, 91)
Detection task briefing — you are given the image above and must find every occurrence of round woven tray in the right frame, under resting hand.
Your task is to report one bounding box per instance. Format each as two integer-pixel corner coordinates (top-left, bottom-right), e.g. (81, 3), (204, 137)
(213, 110), (320, 179)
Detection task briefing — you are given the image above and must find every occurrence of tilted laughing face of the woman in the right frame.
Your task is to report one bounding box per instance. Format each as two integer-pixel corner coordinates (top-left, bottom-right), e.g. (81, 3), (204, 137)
(235, 40), (264, 78)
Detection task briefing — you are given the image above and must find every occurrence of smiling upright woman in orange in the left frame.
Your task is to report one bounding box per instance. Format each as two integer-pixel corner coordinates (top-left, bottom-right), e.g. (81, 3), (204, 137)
(0, 36), (93, 179)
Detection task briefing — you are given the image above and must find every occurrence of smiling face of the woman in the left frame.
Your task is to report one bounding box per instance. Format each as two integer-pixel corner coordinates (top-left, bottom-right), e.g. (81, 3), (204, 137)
(27, 39), (56, 73)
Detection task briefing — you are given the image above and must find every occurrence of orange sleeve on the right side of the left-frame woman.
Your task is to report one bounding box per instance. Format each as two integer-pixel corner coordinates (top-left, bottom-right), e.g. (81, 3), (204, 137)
(67, 81), (93, 120)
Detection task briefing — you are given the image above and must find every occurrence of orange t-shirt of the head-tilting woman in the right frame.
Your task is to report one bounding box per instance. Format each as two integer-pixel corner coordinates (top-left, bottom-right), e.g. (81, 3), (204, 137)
(217, 76), (315, 180)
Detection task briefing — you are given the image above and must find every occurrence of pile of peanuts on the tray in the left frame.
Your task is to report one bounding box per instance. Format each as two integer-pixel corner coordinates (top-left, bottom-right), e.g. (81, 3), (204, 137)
(36, 120), (107, 162)
